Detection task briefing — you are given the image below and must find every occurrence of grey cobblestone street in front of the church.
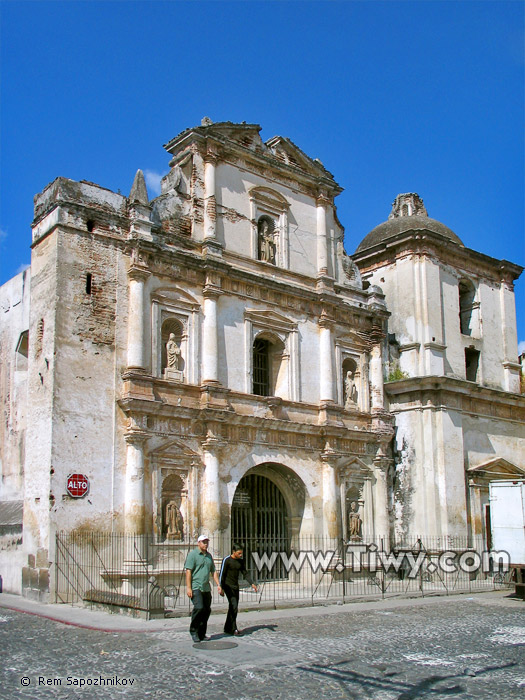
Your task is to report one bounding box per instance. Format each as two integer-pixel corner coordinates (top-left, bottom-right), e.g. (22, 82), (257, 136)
(0, 593), (525, 700)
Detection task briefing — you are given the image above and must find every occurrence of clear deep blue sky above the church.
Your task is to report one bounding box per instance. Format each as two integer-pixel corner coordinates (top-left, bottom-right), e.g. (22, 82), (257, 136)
(0, 0), (525, 349)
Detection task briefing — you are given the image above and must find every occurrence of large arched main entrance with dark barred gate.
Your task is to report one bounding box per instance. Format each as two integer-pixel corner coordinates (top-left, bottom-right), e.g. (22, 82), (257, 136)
(231, 474), (290, 579)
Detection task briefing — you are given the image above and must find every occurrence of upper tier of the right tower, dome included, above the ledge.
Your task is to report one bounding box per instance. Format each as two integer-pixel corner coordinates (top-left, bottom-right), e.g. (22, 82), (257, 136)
(353, 192), (522, 392)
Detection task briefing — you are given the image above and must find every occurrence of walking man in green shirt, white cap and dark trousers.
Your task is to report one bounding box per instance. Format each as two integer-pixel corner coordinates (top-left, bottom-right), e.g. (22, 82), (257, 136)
(184, 535), (222, 642)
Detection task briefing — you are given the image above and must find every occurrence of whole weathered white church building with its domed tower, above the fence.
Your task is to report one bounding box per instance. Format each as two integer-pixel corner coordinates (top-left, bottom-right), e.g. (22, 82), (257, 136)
(0, 120), (525, 596)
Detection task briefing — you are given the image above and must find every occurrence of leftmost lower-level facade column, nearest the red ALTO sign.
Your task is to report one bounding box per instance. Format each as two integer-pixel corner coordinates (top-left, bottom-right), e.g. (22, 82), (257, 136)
(124, 433), (146, 534)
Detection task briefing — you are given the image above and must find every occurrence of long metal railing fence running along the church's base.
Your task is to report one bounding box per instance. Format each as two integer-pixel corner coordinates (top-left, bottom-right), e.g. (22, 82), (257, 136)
(55, 532), (510, 618)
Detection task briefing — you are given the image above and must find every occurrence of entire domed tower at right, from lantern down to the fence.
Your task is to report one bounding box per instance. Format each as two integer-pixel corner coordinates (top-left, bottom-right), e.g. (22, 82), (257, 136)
(352, 192), (525, 537)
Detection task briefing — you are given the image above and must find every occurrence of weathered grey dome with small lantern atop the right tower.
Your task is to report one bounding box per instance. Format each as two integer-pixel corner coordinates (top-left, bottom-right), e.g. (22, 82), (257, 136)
(356, 193), (463, 253)
